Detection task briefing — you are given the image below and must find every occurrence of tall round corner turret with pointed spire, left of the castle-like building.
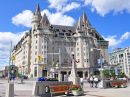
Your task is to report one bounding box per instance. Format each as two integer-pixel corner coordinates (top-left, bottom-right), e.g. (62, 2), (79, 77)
(31, 4), (42, 29)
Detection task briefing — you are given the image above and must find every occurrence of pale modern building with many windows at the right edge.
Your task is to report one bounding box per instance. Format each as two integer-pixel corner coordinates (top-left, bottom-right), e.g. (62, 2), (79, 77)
(109, 47), (130, 76)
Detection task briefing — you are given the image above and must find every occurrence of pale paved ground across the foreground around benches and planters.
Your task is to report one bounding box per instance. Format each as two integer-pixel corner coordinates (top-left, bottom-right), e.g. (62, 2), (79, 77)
(0, 79), (130, 97)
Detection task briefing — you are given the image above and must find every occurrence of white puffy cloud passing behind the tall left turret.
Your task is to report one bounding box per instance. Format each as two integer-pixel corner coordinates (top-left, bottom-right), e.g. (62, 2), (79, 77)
(12, 9), (75, 27)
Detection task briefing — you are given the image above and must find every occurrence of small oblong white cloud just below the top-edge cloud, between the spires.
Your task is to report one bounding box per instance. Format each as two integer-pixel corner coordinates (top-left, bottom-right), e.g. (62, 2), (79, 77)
(62, 2), (80, 13)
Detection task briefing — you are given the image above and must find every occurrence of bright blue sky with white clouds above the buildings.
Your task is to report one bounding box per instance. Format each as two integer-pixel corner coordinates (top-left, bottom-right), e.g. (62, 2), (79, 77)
(0, 0), (130, 68)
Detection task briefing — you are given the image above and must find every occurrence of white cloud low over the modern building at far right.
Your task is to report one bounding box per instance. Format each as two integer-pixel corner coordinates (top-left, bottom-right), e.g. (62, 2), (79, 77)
(104, 32), (130, 49)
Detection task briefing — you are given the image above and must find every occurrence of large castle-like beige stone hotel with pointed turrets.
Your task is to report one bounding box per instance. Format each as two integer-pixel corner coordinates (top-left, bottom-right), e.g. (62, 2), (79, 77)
(13, 4), (109, 78)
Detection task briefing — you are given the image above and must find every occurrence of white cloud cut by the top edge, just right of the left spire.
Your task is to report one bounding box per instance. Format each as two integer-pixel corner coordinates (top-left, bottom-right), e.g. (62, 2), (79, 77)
(48, 0), (68, 11)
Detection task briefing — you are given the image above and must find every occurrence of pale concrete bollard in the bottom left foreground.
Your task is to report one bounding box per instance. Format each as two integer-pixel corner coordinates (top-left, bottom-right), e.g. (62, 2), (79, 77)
(5, 83), (14, 97)
